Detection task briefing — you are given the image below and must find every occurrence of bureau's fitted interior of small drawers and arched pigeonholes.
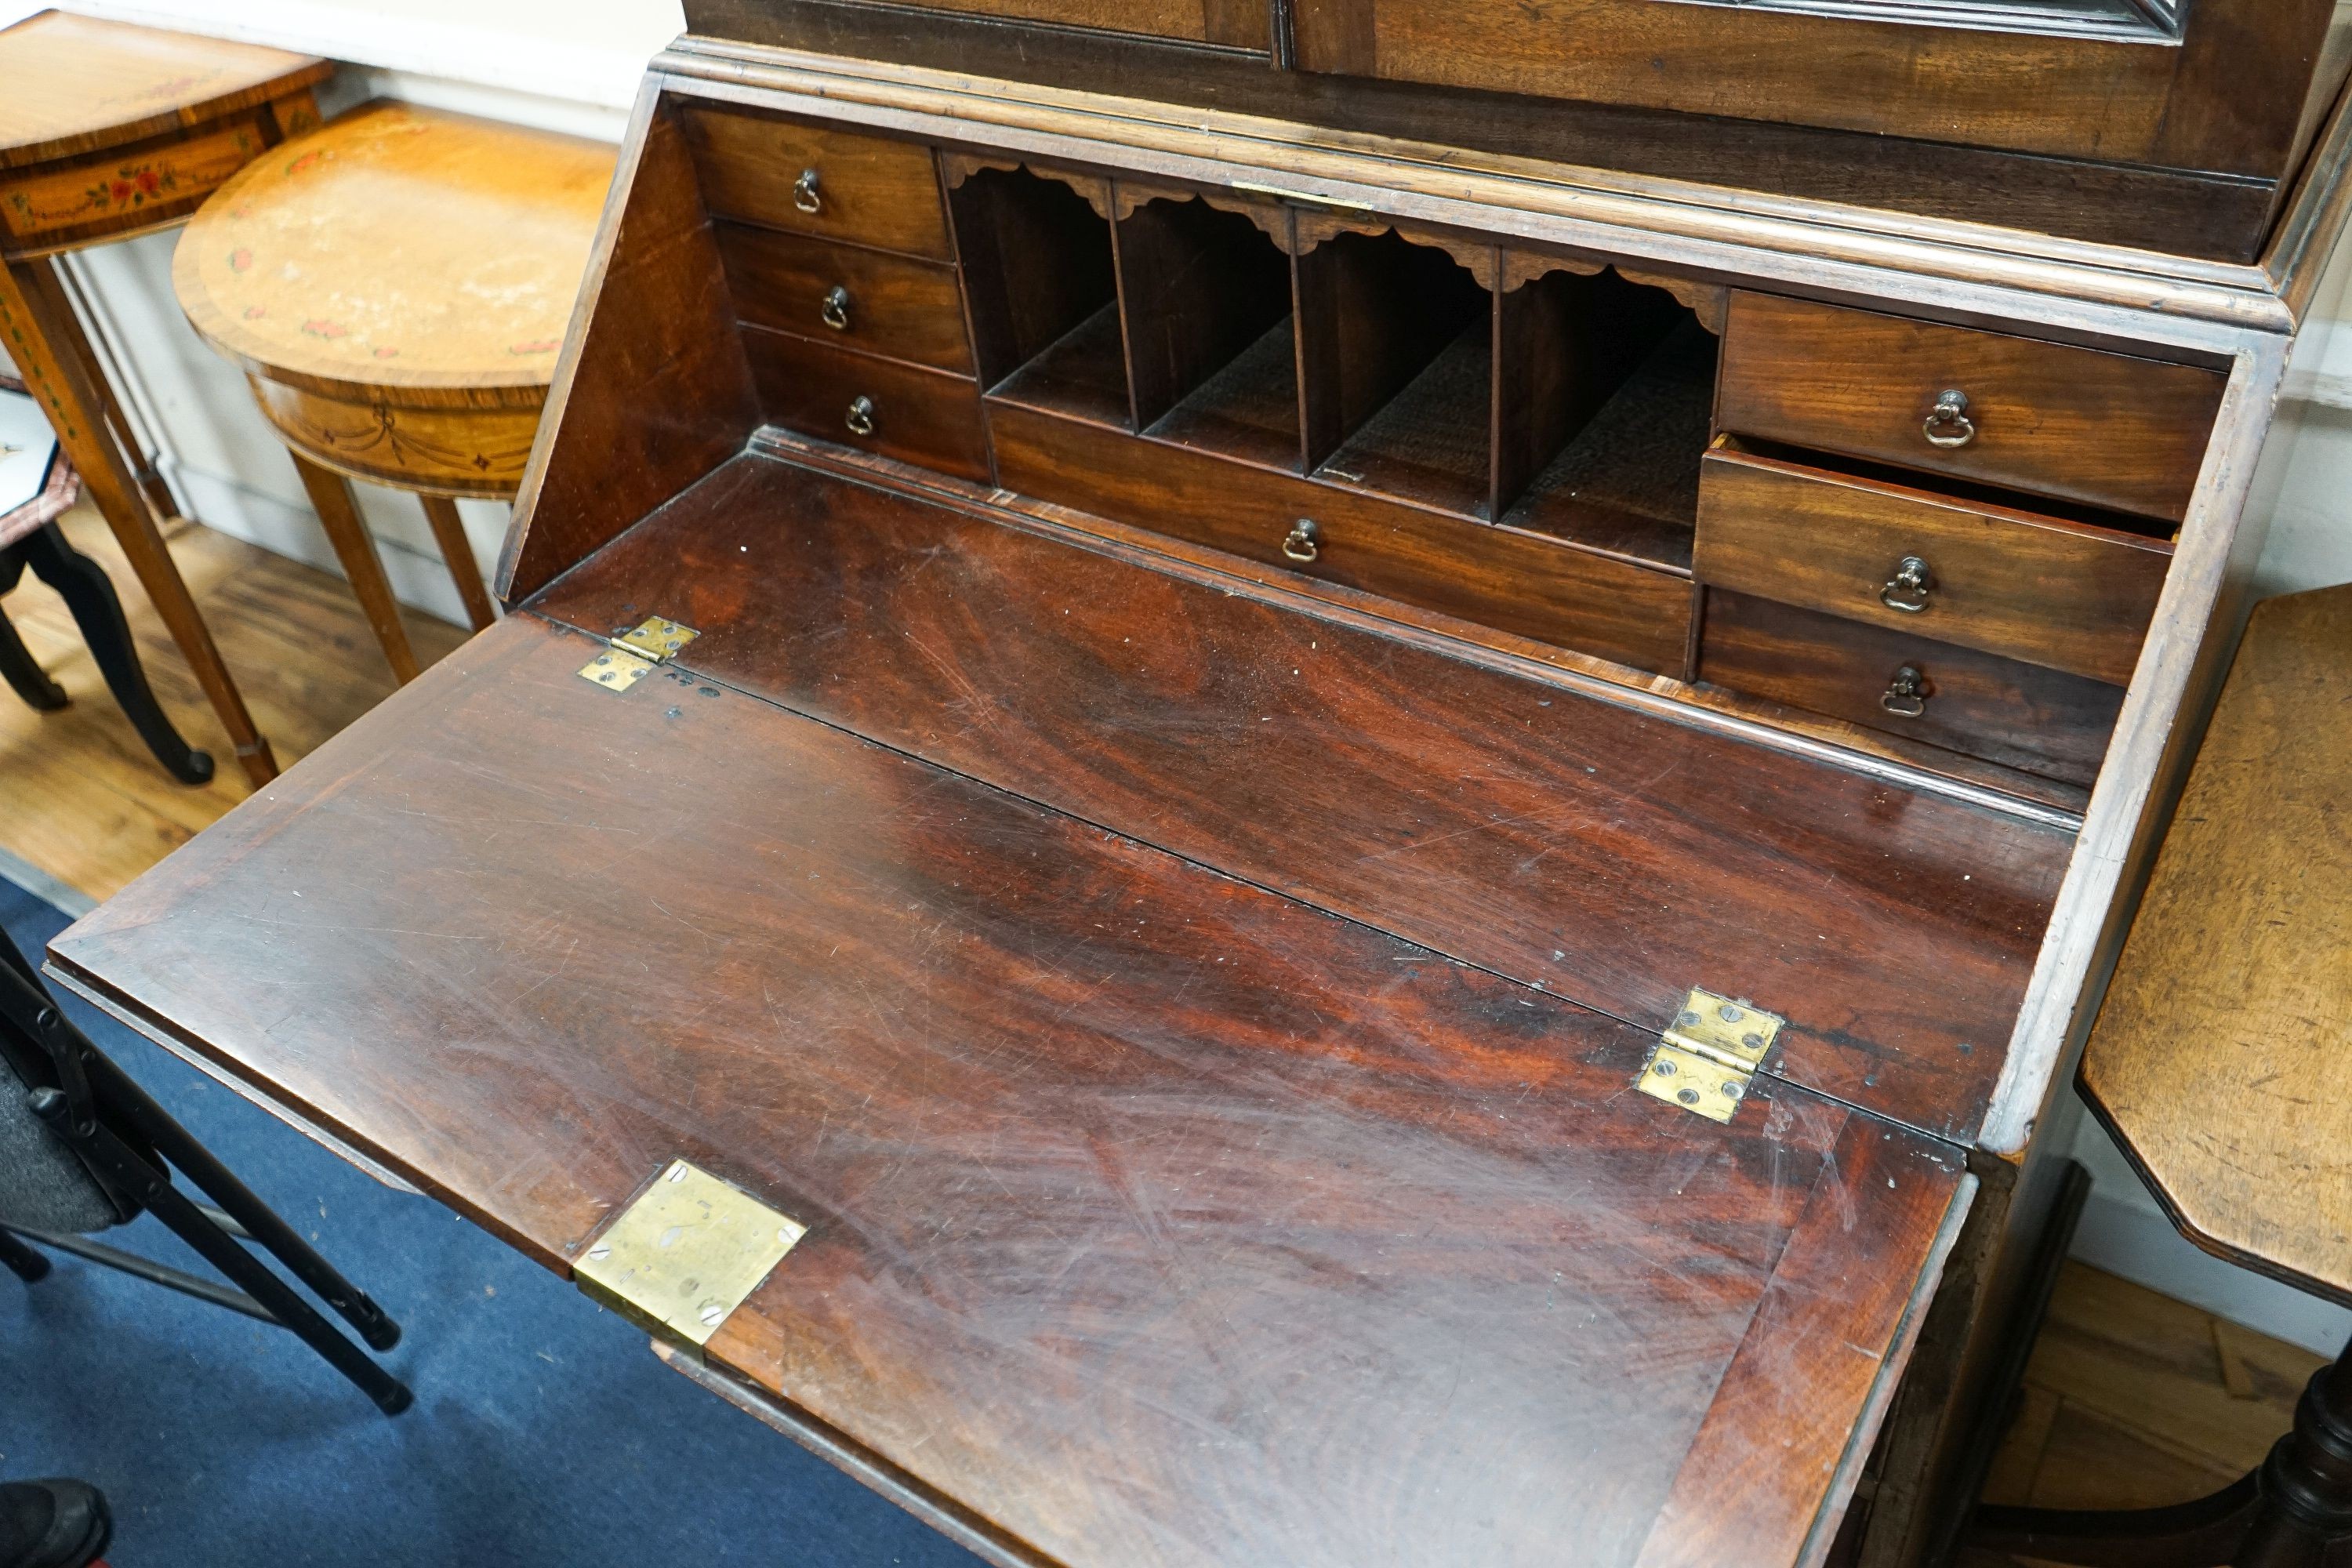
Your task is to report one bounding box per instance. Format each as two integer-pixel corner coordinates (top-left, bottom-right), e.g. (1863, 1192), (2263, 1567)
(517, 99), (2220, 806)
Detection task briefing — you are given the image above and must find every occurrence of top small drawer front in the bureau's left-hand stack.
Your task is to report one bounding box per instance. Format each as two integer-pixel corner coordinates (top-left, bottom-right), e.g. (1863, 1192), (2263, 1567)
(684, 106), (955, 261)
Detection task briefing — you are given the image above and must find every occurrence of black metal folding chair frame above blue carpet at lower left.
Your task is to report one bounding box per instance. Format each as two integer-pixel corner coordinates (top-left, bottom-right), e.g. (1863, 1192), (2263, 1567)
(0, 933), (414, 1415)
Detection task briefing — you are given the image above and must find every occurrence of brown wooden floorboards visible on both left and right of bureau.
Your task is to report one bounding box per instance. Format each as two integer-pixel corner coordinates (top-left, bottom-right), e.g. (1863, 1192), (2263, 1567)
(0, 508), (2321, 1568)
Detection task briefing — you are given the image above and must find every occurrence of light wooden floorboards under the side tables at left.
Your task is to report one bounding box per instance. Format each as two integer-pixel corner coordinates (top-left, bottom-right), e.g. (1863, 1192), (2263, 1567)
(0, 506), (466, 898)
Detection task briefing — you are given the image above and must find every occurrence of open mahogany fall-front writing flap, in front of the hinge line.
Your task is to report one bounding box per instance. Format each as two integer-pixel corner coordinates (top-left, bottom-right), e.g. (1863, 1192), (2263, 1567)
(52, 611), (1959, 1568)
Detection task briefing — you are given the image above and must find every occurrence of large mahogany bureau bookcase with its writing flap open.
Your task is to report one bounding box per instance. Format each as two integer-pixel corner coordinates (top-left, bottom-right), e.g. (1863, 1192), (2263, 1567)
(36, 12), (2352, 1568)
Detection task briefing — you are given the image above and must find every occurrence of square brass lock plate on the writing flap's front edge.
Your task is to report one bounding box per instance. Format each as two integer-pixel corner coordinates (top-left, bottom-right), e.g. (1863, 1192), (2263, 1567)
(572, 1159), (809, 1352)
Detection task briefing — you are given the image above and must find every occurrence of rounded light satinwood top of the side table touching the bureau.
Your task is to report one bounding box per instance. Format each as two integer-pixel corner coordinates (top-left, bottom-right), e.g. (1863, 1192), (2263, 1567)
(172, 103), (614, 407)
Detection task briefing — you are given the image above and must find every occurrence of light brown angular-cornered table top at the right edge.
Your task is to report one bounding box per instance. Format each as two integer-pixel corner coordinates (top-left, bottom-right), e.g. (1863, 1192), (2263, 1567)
(2082, 588), (2352, 1300)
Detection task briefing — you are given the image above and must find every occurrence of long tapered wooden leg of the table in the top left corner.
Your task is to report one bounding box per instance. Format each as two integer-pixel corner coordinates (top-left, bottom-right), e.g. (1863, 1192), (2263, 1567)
(0, 261), (278, 785)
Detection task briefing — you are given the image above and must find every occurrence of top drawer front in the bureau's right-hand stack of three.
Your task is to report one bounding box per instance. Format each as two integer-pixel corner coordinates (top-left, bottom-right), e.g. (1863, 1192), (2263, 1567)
(1715, 292), (2223, 520)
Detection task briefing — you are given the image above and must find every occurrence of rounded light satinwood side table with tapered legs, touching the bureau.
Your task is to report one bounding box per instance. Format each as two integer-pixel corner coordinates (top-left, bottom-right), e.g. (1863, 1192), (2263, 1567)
(172, 103), (614, 682)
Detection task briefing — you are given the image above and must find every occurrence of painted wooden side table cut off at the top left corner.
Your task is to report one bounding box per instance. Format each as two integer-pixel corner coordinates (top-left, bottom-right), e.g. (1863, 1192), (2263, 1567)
(0, 12), (332, 785)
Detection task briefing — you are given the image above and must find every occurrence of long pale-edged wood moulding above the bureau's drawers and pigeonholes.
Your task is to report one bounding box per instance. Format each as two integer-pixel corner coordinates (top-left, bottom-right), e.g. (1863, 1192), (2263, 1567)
(656, 38), (2293, 345)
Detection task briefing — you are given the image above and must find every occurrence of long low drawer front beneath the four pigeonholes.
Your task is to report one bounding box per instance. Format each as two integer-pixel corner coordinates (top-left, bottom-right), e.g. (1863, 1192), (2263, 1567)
(988, 402), (1691, 675)
